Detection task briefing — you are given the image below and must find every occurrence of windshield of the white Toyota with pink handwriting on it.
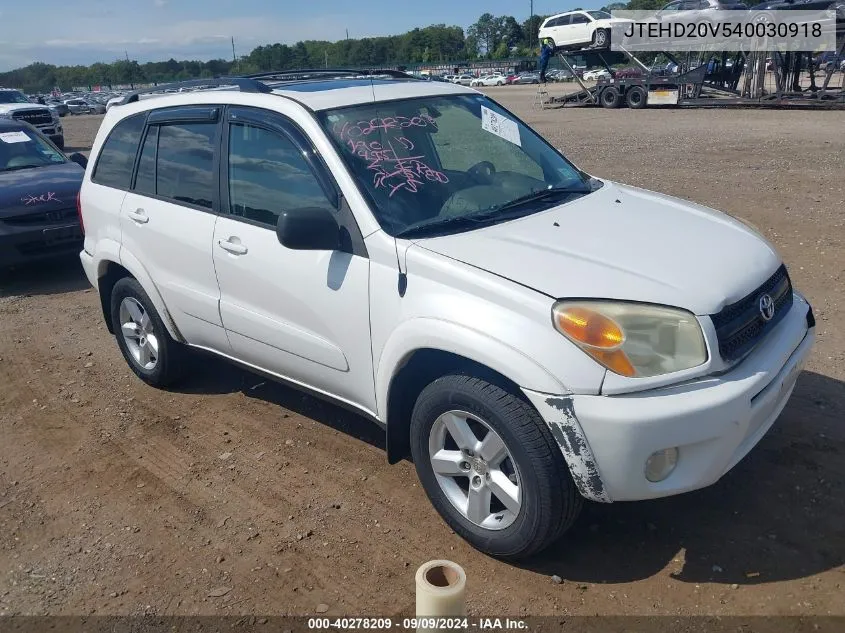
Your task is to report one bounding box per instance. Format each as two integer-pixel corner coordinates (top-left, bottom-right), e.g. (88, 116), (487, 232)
(320, 95), (591, 237)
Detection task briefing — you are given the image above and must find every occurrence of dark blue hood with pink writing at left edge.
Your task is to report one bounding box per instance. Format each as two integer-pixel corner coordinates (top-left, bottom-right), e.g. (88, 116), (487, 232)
(0, 162), (85, 219)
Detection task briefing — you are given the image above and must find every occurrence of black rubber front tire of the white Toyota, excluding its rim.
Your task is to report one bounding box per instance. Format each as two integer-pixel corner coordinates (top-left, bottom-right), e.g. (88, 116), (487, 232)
(411, 376), (572, 558)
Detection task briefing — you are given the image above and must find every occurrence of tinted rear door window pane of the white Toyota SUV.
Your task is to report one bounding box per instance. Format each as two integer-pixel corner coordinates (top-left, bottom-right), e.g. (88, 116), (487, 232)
(155, 123), (217, 209)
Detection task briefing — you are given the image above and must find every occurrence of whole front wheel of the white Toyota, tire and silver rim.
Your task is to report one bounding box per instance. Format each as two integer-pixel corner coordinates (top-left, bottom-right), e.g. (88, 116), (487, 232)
(410, 374), (582, 560)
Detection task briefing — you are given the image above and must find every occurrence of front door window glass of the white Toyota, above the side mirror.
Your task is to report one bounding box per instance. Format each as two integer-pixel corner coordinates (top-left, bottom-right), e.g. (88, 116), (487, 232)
(229, 124), (334, 226)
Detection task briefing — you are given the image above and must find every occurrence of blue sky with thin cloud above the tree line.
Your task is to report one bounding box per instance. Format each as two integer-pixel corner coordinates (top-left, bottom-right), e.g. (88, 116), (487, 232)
(0, 0), (575, 72)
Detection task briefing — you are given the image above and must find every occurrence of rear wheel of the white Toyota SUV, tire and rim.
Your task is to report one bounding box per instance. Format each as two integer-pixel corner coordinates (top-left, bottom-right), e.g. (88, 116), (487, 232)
(111, 277), (184, 387)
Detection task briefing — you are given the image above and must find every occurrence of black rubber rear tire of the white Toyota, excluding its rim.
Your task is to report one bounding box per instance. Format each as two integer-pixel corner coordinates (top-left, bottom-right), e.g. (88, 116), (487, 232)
(111, 277), (177, 387)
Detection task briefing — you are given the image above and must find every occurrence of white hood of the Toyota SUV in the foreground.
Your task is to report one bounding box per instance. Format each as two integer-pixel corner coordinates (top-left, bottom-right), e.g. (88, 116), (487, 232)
(416, 181), (781, 315)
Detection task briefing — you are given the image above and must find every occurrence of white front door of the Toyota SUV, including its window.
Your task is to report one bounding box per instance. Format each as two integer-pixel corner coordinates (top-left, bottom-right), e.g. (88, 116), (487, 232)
(213, 108), (375, 412)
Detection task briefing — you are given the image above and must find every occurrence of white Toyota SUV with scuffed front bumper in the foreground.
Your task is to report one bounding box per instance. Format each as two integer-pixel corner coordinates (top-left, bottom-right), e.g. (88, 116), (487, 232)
(80, 77), (815, 558)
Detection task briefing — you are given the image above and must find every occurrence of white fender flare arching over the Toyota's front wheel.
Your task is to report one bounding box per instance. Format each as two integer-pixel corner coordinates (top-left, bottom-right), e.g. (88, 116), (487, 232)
(376, 317), (569, 423)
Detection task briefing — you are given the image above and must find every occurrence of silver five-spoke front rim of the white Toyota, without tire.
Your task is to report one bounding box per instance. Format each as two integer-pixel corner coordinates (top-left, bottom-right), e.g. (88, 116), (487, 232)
(428, 411), (522, 530)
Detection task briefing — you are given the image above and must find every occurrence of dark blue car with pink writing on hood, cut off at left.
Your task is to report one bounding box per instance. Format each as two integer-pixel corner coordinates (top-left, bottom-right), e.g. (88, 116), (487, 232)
(0, 119), (87, 269)
